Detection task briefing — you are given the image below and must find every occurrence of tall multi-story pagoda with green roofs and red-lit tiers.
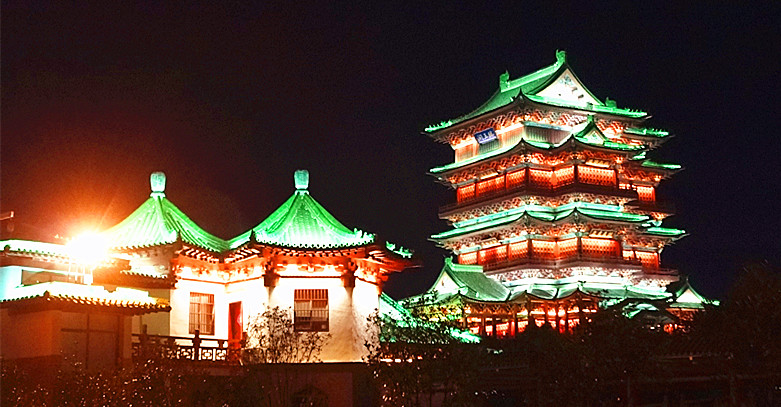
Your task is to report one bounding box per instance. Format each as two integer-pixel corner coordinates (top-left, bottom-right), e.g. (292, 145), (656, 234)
(405, 51), (712, 336)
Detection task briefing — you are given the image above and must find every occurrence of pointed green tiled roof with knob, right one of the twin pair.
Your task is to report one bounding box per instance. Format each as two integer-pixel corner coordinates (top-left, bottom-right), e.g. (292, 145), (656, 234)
(229, 170), (374, 249)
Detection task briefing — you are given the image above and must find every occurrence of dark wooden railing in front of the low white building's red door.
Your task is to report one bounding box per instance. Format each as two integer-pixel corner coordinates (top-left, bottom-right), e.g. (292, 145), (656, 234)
(131, 331), (244, 365)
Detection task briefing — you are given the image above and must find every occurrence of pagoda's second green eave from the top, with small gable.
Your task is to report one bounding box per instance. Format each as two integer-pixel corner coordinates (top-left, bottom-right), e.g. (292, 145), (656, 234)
(429, 118), (646, 174)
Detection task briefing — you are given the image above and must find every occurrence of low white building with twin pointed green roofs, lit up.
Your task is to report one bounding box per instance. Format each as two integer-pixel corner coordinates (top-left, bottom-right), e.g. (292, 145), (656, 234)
(0, 170), (414, 367)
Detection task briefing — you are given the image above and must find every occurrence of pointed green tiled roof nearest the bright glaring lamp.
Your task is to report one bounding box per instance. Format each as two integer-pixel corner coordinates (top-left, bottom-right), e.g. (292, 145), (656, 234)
(103, 172), (228, 253)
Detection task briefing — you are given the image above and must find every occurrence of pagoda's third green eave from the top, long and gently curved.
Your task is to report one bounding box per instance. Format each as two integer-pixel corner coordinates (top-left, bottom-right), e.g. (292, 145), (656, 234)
(431, 202), (650, 240)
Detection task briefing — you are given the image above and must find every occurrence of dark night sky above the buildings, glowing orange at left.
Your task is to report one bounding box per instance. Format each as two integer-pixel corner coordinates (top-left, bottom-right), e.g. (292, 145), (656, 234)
(0, 1), (781, 297)
